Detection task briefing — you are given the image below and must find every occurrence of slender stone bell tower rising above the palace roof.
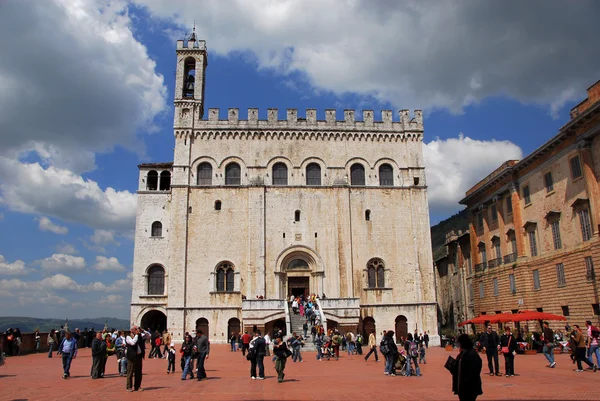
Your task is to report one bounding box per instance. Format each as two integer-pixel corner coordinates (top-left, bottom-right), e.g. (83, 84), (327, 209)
(174, 26), (208, 128)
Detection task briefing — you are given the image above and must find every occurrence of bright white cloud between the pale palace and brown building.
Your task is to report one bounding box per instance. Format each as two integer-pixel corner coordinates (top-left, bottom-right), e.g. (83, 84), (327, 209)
(423, 134), (523, 214)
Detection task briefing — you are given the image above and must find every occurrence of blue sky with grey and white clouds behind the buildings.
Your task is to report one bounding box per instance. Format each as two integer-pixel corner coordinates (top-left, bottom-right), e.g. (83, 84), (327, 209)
(0, 0), (600, 318)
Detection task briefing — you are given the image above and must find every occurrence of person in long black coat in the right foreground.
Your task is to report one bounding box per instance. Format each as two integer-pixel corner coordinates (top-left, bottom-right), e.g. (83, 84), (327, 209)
(452, 334), (483, 401)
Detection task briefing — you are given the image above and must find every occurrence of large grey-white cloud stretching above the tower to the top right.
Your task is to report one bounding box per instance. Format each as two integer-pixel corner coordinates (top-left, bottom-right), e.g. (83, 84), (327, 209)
(134, 0), (600, 112)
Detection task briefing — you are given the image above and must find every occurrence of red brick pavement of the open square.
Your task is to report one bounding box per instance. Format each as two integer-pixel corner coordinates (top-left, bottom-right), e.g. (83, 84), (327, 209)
(0, 345), (600, 401)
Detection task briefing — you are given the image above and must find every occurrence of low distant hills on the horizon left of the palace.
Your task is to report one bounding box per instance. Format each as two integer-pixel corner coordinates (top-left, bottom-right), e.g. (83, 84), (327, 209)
(0, 316), (129, 333)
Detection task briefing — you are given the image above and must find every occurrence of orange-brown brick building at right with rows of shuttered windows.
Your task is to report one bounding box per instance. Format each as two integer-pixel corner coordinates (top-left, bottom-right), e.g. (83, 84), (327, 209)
(461, 81), (600, 326)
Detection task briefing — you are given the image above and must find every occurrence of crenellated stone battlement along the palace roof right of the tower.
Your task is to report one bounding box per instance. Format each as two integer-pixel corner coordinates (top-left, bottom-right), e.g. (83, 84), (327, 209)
(194, 108), (423, 132)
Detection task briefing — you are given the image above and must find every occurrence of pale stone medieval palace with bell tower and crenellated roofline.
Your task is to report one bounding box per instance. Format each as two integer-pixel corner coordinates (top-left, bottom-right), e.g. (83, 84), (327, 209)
(131, 37), (438, 343)
